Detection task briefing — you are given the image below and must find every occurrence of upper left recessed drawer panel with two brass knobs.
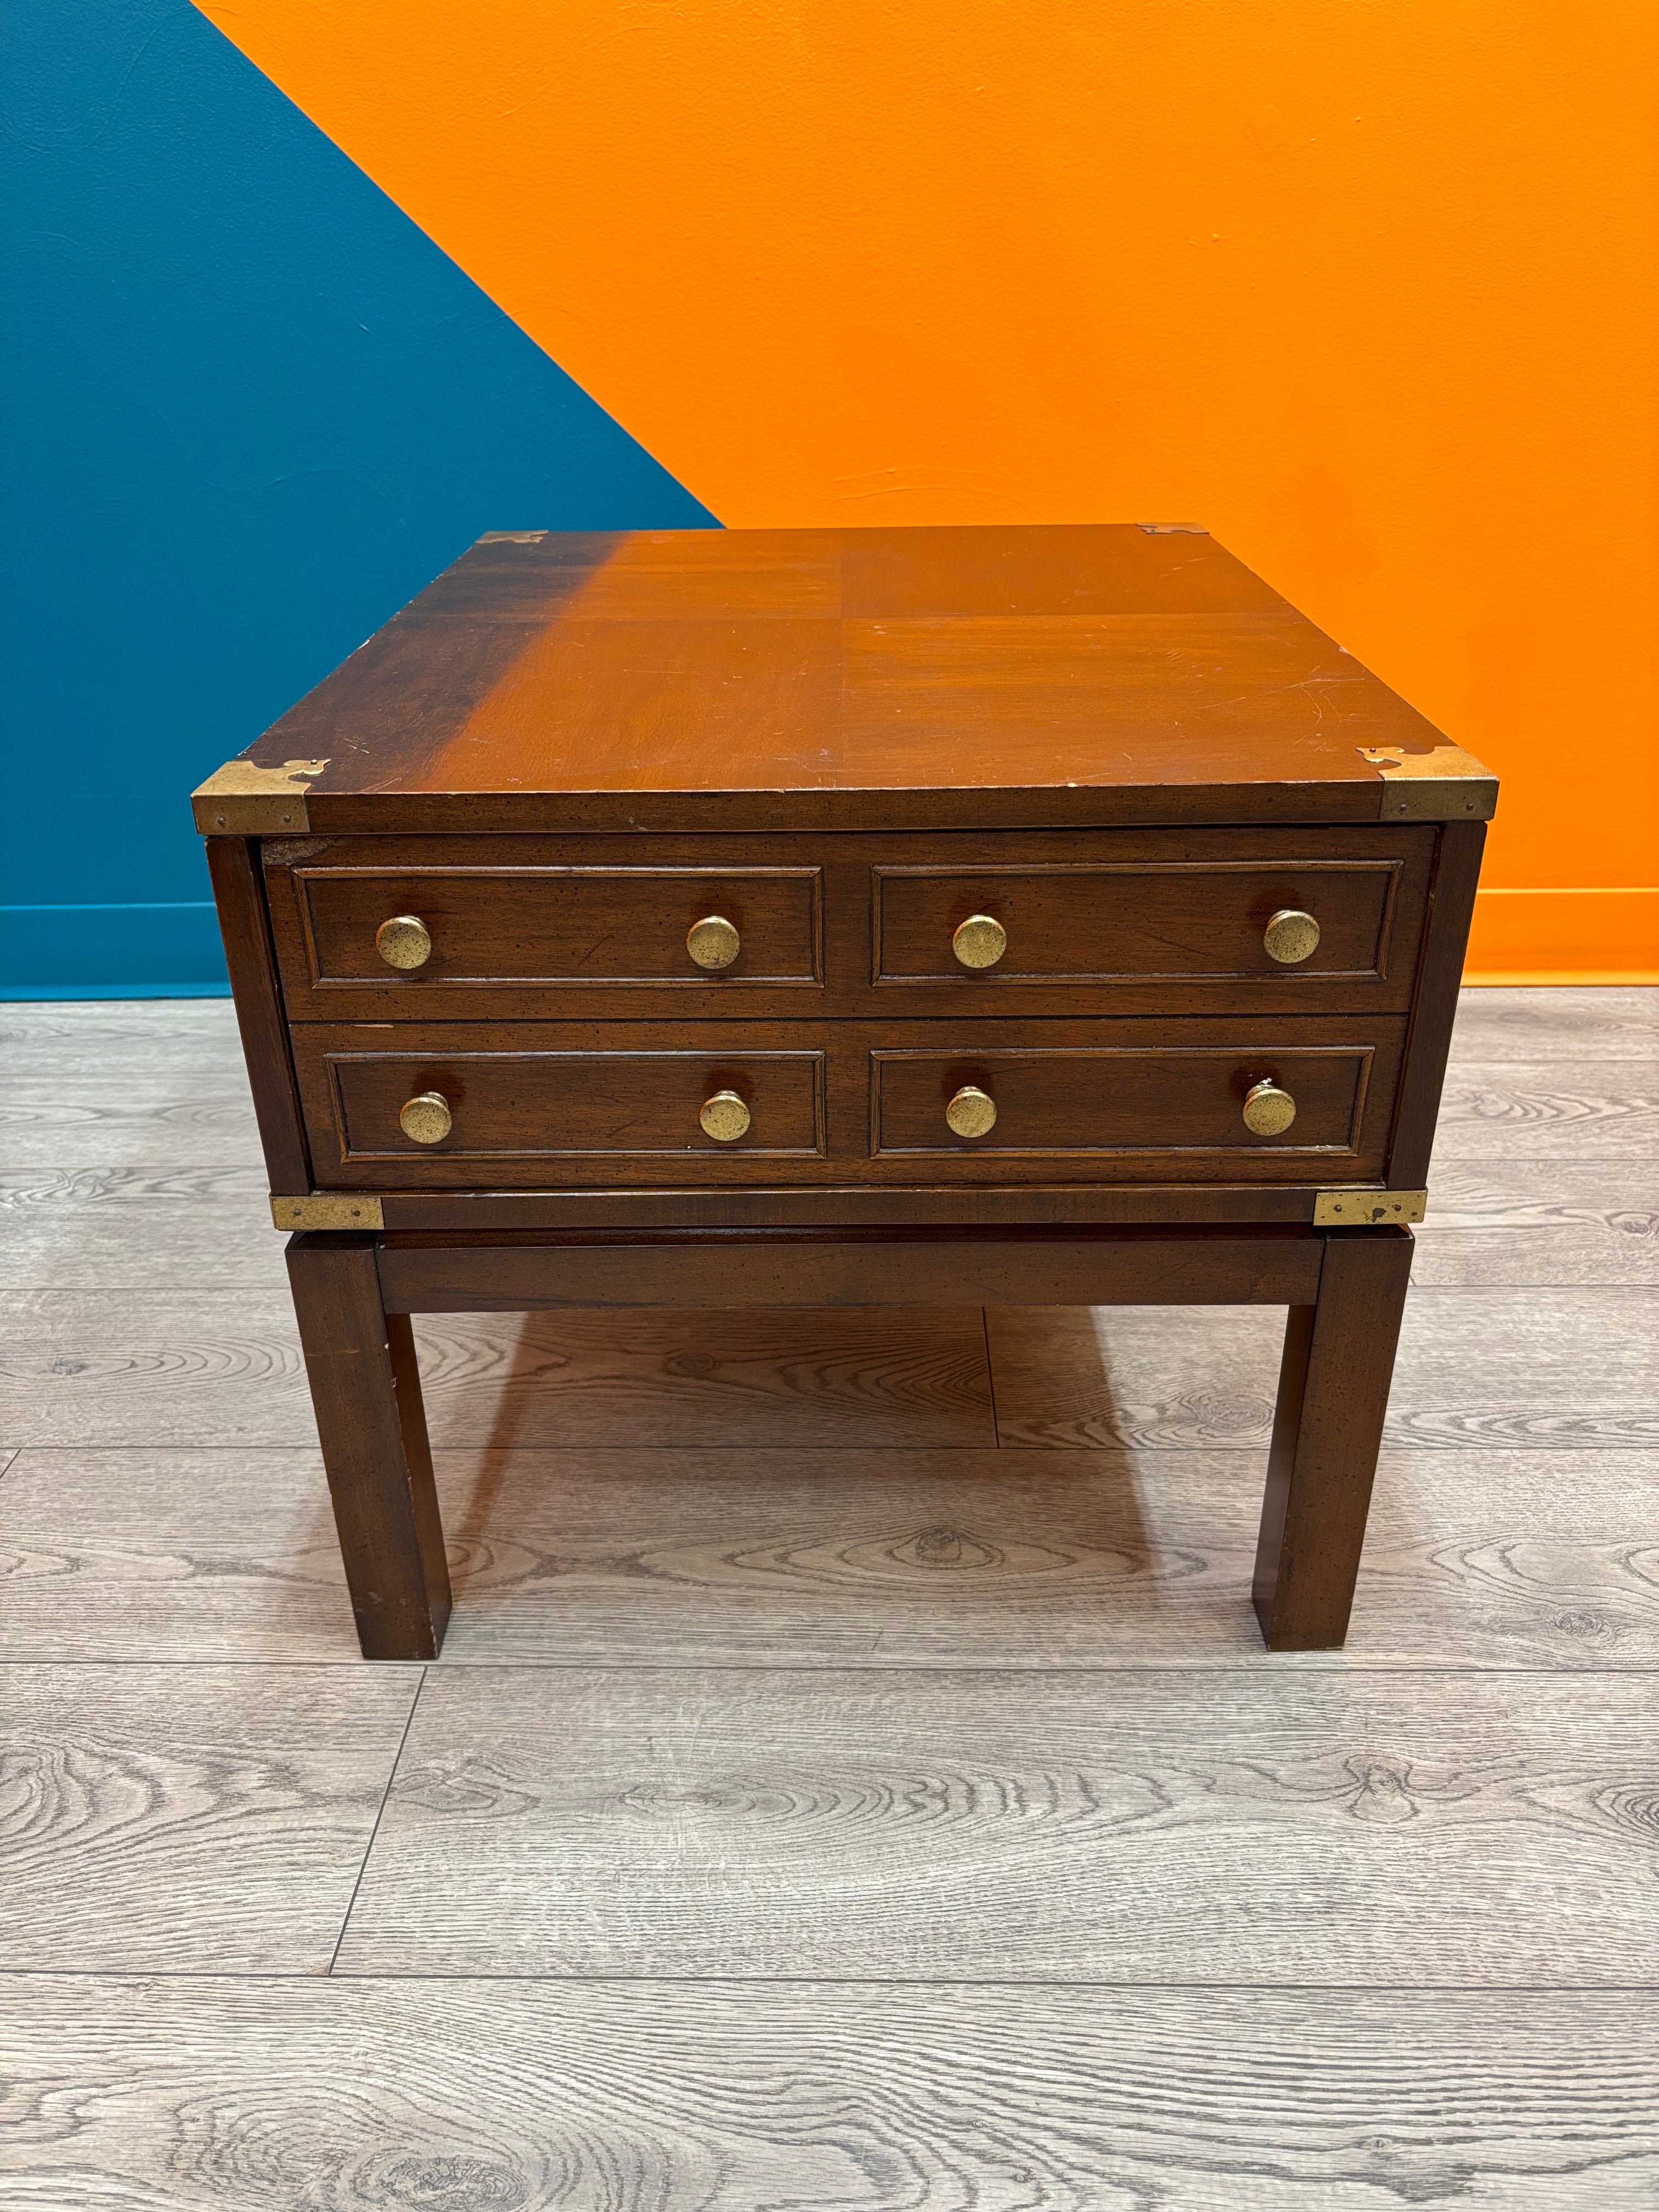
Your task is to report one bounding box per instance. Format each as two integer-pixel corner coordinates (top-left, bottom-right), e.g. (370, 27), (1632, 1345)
(270, 838), (823, 1015)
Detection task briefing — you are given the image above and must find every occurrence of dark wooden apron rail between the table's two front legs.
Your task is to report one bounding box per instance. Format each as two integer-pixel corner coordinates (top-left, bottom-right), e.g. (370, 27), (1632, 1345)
(381, 1230), (1321, 1314)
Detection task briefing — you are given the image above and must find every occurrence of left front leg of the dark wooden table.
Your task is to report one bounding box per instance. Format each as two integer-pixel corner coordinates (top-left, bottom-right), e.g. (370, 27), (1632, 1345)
(287, 1237), (449, 1659)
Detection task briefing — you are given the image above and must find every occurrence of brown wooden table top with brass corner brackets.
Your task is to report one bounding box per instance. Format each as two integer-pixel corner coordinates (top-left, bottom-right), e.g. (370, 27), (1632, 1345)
(197, 524), (1496, 834)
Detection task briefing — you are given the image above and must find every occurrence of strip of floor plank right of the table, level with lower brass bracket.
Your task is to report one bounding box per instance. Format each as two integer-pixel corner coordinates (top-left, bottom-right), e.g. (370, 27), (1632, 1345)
(1411, 1159), (1659, 1290)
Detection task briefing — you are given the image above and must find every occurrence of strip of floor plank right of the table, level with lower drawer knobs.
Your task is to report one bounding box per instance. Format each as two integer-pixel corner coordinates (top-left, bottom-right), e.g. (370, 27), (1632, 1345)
(1429, 1057), (1659, 1177)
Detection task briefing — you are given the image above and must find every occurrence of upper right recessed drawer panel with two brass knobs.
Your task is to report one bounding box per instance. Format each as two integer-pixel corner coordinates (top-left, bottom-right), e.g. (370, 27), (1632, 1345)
(874, 858), (1404, 991)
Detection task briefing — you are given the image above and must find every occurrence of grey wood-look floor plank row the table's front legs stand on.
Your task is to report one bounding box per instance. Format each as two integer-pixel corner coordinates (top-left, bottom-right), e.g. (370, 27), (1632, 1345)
(0, 1447), (1659, 1672)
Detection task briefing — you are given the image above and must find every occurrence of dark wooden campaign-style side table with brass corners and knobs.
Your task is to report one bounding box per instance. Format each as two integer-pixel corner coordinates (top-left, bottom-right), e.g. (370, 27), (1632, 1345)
(195, 524), (1496, 1659)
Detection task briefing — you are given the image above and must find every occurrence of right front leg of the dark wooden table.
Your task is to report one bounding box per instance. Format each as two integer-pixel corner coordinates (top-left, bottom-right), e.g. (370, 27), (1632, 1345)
(1252, 1230), (1411, 1650)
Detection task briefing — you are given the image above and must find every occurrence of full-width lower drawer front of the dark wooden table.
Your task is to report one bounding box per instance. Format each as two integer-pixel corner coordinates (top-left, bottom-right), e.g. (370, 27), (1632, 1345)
(294, 1018), (1404, 1190)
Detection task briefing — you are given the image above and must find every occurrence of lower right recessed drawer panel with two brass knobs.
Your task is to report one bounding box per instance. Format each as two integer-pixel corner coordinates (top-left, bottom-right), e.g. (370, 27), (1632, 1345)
(872, 1040), (1376, 1175)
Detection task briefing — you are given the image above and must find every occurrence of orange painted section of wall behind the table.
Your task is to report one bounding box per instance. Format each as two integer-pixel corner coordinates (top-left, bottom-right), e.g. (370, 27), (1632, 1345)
(201, 0), (1659, 975)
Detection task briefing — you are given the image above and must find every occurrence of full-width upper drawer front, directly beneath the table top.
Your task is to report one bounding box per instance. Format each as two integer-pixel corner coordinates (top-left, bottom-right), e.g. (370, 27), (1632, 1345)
(266, 823), (1438, 1022)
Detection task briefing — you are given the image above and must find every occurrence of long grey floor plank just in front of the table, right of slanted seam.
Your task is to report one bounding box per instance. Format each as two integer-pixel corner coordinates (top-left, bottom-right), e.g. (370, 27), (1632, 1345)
(338, 1666), (1659, 1989)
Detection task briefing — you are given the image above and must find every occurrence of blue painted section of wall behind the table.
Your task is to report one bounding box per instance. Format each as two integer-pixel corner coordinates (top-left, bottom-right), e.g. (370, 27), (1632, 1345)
(0, 0), (714, 997)
